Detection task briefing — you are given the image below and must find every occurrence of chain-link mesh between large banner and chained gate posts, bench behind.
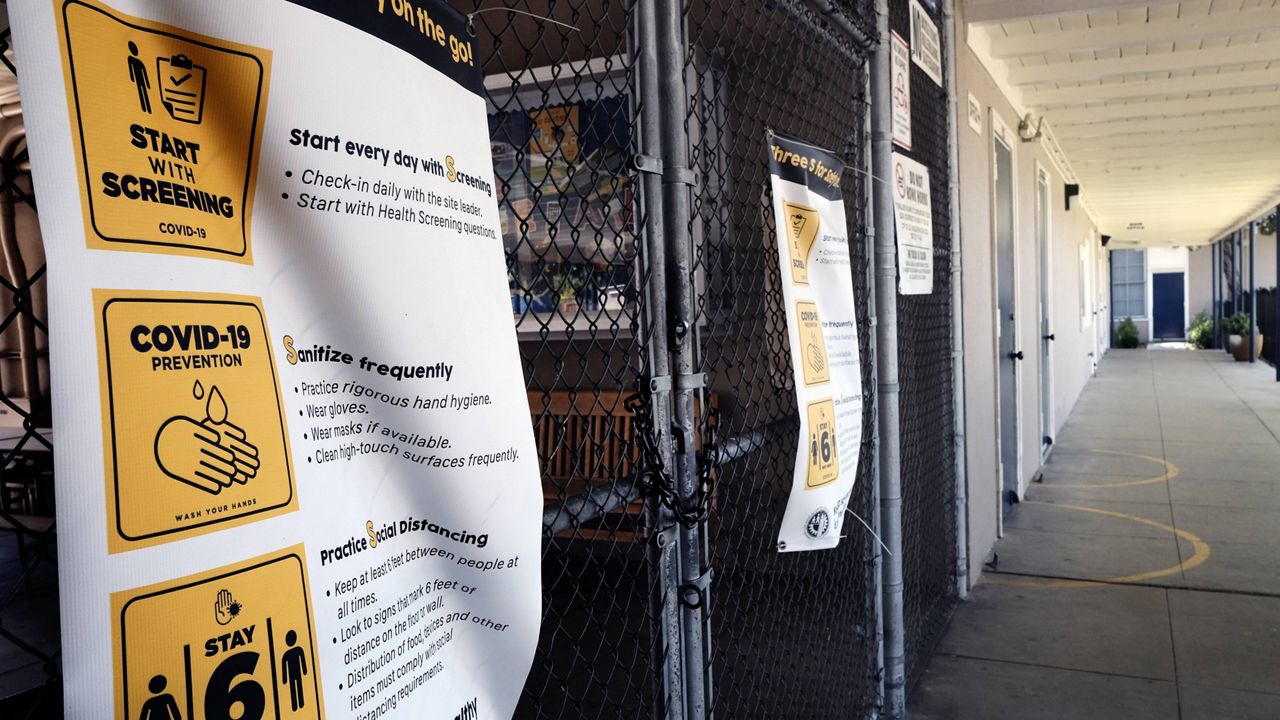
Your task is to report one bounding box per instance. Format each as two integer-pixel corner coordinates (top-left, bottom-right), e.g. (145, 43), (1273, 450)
(458, 0), (666, 717)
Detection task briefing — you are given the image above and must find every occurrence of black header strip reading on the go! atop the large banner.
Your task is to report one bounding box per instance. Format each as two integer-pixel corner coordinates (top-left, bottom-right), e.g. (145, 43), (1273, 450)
(289, 0), (484, 96)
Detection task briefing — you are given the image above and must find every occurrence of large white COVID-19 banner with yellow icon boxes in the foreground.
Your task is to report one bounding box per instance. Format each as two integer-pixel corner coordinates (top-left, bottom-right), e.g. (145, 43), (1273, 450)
(10, 0), (543, 720)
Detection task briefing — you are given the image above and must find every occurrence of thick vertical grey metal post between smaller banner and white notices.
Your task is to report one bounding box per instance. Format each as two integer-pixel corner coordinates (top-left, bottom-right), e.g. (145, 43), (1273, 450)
(870, 0), (906, 717)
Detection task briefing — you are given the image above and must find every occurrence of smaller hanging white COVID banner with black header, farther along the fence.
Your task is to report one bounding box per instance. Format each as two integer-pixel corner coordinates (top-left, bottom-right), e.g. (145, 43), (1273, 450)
(768, 132), (863, 552)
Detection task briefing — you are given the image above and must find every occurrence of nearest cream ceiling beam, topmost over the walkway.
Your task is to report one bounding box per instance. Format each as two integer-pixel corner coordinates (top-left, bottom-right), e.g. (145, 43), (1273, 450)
(991, 6), (1280, 60)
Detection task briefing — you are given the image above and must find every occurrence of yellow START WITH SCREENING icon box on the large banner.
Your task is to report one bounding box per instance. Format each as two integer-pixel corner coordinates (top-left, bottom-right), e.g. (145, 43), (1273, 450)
(59, 0), (271, 264)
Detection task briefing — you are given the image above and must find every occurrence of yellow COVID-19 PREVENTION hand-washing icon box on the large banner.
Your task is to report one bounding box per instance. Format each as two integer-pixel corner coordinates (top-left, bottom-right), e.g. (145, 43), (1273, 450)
(93, 290), (297, 552)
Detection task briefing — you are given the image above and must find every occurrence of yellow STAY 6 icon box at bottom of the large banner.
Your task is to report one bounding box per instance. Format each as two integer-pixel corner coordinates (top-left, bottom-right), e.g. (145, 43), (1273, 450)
(111, 544), (324, 720)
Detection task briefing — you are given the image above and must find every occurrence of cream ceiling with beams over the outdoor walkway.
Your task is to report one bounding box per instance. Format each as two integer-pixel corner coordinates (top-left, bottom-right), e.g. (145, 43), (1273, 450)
(963, 0), (1280, 246)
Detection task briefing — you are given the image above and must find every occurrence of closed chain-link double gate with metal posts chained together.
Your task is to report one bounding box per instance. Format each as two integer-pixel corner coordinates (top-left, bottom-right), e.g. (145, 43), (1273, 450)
(476, 0), (878, 717)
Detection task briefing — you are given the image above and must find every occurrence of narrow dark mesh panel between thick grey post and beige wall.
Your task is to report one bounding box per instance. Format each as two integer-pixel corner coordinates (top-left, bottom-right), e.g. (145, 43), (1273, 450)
(888, 0), (956, 682)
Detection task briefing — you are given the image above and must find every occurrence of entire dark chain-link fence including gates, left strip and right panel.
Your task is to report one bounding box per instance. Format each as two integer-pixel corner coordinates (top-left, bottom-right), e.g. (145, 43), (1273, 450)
(0, 0), (955, 717)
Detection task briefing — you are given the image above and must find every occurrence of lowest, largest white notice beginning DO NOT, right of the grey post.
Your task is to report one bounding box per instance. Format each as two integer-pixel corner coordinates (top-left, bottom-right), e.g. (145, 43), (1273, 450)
(892, 152), (933, 295)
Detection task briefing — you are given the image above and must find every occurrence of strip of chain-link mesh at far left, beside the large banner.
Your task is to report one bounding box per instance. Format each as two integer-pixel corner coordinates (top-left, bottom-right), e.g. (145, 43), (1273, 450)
(0, 28), (61, 717)
